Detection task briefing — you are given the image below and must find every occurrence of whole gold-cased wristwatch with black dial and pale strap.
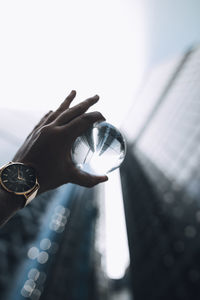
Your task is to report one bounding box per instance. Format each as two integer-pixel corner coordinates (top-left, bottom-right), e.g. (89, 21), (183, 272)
(0, 162), (40, 207)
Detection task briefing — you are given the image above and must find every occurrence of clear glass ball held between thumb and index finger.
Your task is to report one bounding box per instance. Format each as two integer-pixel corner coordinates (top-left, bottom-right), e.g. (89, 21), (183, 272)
(71, 122), (126, 175)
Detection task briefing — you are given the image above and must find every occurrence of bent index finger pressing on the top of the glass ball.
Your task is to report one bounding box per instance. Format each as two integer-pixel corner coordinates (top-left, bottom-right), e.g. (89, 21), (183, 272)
(63, 111), (106, 143)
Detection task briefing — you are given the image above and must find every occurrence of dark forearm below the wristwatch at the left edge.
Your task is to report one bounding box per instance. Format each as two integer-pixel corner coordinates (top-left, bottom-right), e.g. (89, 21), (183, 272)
(0, 187), (24, 226)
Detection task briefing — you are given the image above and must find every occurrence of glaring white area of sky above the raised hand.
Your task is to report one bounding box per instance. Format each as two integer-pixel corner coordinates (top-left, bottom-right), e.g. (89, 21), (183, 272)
(0, 0), (145, 126)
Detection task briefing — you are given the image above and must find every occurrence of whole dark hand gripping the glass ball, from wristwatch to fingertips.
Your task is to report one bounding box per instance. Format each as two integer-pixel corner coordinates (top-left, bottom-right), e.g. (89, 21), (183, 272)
(13, 91), (108, 193)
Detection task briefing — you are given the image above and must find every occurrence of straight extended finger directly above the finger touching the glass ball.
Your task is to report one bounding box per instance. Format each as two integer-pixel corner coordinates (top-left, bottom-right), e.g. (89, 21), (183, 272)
(56, 95), (99, 126)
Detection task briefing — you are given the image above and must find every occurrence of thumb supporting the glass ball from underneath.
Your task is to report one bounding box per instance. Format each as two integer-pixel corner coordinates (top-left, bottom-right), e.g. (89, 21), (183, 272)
(72, 169), (108, 187)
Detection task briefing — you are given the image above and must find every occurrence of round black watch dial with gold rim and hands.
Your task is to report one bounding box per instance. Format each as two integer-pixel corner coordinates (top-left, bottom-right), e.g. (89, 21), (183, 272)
(1, 163), (36, 193)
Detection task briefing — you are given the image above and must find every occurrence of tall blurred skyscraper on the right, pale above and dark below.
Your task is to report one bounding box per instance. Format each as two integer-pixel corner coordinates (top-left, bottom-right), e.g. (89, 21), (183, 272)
(121, 47), (200, 300)
